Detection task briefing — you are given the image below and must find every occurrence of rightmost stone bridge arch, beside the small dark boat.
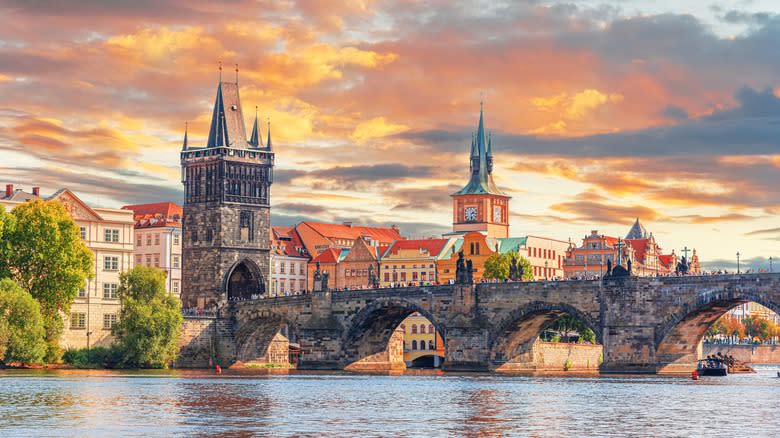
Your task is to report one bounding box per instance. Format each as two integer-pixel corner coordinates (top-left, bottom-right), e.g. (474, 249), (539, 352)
(655, 282), (780, 373)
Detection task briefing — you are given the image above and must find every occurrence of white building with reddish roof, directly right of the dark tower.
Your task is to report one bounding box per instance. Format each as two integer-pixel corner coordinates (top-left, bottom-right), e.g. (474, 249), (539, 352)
(271, 227), (309, 297)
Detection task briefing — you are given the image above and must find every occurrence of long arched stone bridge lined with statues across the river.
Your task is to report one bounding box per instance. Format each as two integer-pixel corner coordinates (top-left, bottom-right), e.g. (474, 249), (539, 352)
(180, 274), (780, 373)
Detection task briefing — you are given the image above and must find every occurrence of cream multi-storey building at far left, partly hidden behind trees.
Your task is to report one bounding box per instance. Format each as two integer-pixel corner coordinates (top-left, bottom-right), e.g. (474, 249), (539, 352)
(0, 184), (135, 349)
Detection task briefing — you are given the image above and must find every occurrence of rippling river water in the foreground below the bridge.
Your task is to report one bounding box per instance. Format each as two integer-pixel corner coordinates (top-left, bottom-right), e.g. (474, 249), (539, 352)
(0, 368), (780, 437)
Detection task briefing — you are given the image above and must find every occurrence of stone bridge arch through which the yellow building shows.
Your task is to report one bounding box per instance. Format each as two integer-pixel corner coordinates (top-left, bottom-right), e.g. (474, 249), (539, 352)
(341, 297), (447, 371)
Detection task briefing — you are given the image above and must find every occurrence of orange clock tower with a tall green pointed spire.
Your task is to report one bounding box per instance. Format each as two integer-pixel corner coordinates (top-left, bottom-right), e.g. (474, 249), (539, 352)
(452, 104), (511, 238)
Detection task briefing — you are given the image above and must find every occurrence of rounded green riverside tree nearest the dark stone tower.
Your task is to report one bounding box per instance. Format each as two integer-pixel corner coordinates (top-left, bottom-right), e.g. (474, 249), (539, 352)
(114, 266), (184, 368)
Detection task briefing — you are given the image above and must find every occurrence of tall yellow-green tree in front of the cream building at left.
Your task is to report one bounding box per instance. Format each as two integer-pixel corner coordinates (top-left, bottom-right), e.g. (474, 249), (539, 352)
(0, 199), (94, 362)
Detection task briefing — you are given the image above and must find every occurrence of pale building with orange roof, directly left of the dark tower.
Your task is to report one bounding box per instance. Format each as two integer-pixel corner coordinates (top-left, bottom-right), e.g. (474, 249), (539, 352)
(122, 202), (183, 297)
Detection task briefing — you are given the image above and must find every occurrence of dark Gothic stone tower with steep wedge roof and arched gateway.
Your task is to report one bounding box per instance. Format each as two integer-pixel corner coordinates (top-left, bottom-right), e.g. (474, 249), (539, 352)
(181, 74), (274, 308)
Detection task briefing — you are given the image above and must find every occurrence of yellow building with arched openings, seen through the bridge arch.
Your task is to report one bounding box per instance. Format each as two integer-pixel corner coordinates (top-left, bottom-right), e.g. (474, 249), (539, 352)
(401, 312), (444, 367)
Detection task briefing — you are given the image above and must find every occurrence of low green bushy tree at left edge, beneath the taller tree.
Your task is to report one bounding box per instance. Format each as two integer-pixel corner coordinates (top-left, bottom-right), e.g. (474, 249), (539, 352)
(0, 278), (46, 363)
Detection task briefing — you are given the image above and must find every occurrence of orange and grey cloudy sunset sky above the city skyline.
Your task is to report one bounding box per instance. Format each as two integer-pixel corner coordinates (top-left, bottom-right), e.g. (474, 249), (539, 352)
(0, 0), (780, 269)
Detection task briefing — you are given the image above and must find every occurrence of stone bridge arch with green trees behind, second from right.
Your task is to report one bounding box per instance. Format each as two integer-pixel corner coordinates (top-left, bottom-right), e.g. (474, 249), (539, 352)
(488, 301), (602, 371)
